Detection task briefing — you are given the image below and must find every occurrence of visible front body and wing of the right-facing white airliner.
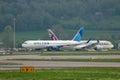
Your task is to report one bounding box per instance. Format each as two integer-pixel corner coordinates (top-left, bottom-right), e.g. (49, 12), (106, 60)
(73, 40), (113, 51)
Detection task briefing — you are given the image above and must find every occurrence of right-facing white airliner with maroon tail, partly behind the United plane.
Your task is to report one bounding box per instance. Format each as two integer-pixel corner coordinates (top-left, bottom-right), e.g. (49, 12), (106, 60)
(48, 29), (114, 51)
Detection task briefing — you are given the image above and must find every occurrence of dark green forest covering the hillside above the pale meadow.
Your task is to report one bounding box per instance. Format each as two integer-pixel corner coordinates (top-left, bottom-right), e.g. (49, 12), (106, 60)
(0, 0), (120, 31)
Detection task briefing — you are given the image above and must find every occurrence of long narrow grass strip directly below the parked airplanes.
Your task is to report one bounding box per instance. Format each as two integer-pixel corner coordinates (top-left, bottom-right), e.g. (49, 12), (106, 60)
(5, 50), (120, 56)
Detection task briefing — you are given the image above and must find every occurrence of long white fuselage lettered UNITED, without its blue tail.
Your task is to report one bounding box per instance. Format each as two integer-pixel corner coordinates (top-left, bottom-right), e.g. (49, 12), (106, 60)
(22, 40), (79, 48)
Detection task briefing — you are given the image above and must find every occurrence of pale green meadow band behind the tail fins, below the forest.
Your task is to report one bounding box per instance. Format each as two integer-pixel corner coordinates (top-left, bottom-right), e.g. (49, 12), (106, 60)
(0, 30), (119, 41)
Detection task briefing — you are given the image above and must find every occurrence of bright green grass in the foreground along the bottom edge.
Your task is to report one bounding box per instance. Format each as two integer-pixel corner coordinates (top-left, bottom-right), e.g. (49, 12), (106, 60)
(0, 67), (120, 80)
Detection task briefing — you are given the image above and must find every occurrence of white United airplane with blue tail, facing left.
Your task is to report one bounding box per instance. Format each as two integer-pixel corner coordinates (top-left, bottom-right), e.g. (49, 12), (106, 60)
(22, 28), (84, 50)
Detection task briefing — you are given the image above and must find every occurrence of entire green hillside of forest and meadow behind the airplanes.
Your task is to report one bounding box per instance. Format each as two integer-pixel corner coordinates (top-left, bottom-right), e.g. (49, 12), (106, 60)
(0, 0), (120, 46)
